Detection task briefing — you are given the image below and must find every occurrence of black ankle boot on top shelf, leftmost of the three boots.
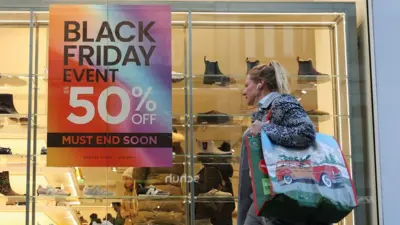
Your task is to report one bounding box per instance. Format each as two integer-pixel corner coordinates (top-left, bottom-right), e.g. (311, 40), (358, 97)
(203, 56), (230, 86)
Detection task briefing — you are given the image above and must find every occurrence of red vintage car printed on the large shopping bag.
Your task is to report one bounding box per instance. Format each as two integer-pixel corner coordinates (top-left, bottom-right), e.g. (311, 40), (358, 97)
(276, 160), (342, 188)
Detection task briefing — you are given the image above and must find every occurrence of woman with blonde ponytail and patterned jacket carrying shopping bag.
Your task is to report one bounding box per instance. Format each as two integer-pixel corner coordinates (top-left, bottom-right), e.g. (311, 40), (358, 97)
(238, 61), (324, 225)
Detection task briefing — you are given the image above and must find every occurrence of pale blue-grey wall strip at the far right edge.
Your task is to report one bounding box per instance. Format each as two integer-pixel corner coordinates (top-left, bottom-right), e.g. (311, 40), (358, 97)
(370, 0), (400, 225)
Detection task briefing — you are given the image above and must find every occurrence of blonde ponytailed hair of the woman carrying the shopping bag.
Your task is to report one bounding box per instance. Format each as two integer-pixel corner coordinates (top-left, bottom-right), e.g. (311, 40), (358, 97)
(248, 61), (290, 94)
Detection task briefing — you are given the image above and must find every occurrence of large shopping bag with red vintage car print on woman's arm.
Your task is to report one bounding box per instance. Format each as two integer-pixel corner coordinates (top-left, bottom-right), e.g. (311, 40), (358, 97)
(246, 131), (358, 223)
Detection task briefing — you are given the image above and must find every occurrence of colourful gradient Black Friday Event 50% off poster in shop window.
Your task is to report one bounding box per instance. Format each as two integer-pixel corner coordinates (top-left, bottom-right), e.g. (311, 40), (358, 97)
(47, 5), (172, 167)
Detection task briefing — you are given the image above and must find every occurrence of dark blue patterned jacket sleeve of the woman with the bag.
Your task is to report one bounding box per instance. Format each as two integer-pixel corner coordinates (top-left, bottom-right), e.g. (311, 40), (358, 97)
(261, 94), (316, 148)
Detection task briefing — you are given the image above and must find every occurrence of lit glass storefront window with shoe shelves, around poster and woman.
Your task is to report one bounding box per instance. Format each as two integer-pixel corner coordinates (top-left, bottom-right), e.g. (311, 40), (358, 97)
(0, 2), (377, 225)
